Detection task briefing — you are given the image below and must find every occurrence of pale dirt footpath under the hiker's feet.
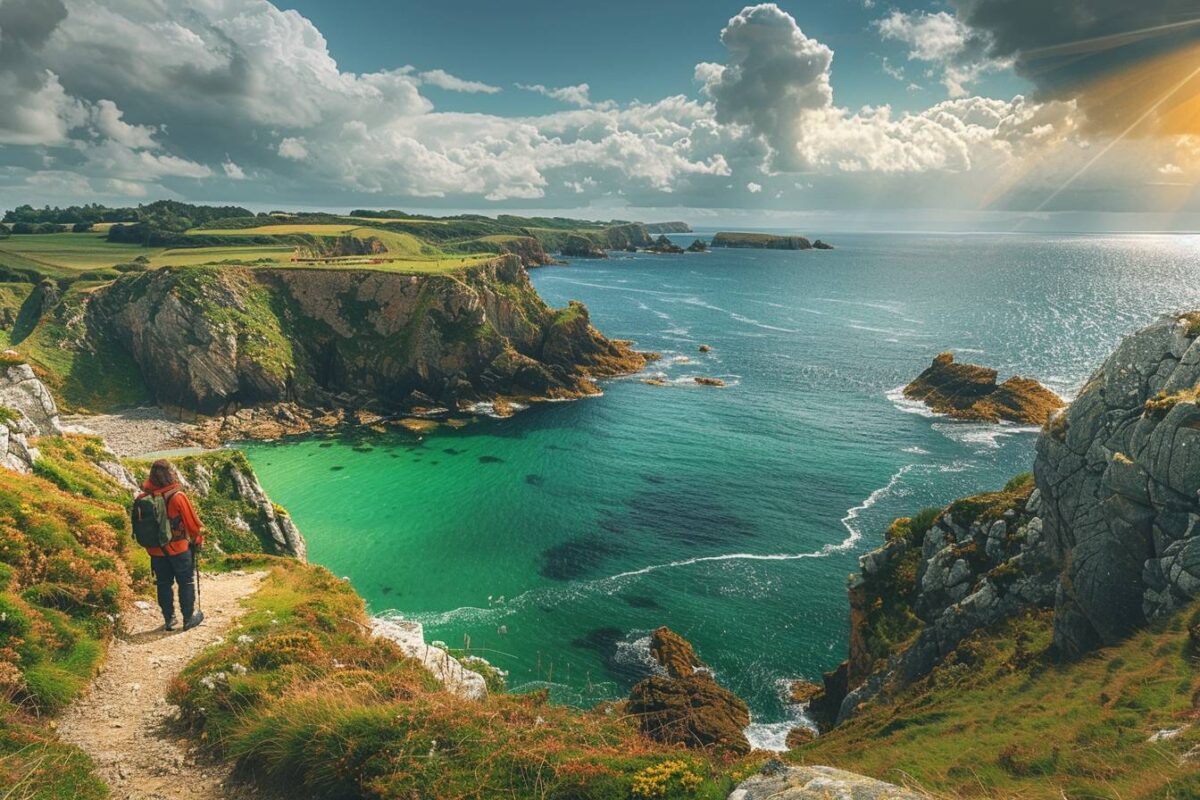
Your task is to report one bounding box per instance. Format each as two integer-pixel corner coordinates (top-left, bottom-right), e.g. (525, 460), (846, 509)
(59, 572), (265, 800)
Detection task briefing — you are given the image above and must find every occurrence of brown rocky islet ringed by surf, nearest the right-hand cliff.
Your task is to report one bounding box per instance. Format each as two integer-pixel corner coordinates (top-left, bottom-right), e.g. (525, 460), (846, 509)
(904, 353), (1067, 425)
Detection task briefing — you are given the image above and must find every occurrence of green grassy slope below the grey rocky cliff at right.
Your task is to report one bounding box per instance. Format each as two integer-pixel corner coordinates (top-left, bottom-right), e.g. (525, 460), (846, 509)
(788, 608), (1200, 800)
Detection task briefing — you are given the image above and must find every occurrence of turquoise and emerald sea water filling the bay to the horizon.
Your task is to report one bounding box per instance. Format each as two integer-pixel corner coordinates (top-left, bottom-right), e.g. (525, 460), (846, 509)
(241, 235), (1200, 739)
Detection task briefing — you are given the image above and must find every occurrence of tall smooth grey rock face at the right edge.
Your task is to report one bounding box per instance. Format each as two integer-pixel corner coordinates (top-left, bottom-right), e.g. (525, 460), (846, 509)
(1034, 313), (1200, 654)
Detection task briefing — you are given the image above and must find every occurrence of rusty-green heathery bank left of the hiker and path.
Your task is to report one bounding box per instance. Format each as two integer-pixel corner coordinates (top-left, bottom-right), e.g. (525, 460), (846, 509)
(0, 437), (149, 800)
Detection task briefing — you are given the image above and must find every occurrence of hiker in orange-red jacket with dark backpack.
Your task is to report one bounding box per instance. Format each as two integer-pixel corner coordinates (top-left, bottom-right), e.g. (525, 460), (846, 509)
(132, 459), (204, 631)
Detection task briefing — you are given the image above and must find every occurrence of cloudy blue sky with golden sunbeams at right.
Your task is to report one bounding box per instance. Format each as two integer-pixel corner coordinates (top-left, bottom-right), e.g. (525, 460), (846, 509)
(0, 0), (1200, 230)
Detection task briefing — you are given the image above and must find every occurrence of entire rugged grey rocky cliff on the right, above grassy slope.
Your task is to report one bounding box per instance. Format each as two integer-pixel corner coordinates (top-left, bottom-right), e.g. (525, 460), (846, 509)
(812, 313), (1200, 724)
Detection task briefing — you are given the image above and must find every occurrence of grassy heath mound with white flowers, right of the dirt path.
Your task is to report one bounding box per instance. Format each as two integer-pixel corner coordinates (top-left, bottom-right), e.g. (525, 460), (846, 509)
(170, 559), (739, 800)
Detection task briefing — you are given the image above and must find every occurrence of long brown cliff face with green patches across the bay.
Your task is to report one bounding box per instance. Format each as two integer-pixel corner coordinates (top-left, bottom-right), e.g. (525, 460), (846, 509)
(86, 255), (646, 414)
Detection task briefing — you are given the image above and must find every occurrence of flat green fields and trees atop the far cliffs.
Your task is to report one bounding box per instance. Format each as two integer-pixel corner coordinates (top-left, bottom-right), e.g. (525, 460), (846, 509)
(0, 203), (657, 281)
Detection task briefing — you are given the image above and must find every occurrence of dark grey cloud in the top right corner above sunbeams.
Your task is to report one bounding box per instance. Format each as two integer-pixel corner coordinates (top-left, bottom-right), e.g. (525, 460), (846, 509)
(950, 0), (1200, 94)
